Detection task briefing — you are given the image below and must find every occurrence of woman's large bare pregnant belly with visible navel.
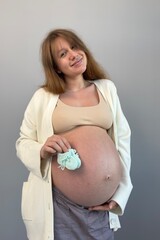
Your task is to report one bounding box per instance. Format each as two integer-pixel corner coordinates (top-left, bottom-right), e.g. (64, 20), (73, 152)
(52, 126), (122, 206)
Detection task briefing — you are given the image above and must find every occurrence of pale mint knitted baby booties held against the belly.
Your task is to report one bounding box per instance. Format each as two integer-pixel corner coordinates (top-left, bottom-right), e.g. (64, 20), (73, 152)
(57, 148), (81, 170)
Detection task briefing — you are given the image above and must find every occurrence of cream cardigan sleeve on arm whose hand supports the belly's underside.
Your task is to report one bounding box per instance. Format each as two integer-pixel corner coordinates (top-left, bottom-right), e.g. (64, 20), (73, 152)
(106, 82), (133, 215)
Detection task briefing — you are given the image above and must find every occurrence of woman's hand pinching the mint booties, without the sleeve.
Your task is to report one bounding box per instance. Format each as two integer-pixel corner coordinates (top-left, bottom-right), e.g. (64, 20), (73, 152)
(40, 135), (71, 159)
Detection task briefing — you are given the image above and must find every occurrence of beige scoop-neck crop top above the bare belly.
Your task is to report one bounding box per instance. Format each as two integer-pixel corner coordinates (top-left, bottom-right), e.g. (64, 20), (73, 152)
(52, 90), (113, 134)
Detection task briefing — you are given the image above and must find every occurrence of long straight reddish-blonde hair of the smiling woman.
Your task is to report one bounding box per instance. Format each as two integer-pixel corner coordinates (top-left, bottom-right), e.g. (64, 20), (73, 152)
(41, 29), (107, 94)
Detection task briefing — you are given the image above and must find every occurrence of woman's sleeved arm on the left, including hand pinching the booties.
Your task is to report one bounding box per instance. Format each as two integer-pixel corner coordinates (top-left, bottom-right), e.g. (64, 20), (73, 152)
(16, 89), (71, 178)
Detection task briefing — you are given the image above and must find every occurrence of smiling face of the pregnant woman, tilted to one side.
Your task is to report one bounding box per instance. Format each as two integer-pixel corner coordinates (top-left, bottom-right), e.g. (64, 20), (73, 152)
(53, 37), (87, 79)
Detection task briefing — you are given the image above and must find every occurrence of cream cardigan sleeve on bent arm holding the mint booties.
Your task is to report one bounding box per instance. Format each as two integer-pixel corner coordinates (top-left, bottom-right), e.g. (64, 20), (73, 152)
(16, 91), (49, 178)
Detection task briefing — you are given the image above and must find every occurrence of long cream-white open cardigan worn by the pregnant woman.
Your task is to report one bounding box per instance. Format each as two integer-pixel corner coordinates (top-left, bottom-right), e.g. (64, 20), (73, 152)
(16, 79), (132, 240)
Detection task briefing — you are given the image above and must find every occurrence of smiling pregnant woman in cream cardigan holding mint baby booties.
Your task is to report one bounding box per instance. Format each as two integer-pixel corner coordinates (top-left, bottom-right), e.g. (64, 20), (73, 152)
(16, 29), (132, 240)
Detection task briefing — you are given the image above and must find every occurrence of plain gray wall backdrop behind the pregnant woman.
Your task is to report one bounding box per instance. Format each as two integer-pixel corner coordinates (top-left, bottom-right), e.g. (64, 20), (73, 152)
(0, 0), (160, 240)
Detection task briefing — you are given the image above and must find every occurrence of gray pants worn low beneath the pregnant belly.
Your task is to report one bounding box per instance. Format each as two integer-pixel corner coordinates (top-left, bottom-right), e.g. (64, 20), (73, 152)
(53, 188), (114, 240)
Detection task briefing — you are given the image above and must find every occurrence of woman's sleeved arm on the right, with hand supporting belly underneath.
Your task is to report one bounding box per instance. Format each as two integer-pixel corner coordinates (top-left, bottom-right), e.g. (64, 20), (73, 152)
(91, 80), (132, 215)
